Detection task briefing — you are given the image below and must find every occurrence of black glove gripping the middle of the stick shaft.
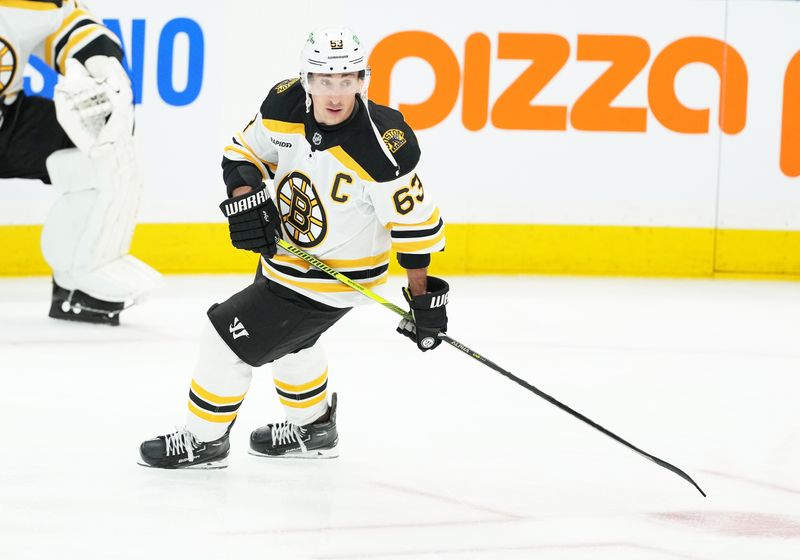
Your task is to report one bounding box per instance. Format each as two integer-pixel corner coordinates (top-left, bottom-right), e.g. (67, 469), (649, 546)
(397, 276), (450, 352)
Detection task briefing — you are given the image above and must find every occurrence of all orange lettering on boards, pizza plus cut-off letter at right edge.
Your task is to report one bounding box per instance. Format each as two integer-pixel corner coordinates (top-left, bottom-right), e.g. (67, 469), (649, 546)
(370, 31), (752, 139)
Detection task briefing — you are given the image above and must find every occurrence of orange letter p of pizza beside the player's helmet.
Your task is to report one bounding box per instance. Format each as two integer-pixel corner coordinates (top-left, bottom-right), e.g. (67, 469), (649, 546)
(369, 31), (461, 130)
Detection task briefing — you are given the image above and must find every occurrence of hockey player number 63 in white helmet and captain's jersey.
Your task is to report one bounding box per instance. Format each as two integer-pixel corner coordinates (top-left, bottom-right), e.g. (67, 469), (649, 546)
(139, 28), (449, 468)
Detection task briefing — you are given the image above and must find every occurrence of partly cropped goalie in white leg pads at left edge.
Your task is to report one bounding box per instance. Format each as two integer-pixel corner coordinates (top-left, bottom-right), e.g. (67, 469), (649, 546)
(0, 0), (159, 325)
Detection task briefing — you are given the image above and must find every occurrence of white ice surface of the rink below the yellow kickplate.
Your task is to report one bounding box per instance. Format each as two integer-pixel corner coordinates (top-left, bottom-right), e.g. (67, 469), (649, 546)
(0, 276), (800, 560)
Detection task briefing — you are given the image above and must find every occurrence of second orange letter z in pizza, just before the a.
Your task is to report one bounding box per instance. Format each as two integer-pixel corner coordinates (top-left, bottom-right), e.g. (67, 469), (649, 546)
(570, 35), (650, 132)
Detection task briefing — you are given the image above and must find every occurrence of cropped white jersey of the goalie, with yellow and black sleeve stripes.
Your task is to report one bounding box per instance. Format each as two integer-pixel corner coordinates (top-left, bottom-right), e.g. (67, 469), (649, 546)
(0, 0), (122, 98)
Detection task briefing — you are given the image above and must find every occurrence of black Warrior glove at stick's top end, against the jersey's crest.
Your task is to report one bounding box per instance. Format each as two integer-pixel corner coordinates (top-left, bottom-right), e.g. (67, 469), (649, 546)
(219, 185), (281, 258)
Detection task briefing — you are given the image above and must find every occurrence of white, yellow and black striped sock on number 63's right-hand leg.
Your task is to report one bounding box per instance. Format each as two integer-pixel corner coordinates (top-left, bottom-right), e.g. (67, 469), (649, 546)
(272, 343), (328, 426)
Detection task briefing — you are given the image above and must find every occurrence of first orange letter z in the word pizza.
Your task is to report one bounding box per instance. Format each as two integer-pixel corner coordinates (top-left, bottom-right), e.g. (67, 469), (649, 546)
(492, 33), (569, 130)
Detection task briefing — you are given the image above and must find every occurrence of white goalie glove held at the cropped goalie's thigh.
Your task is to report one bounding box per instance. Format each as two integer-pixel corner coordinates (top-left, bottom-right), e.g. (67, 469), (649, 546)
(53, 55), (133, 157)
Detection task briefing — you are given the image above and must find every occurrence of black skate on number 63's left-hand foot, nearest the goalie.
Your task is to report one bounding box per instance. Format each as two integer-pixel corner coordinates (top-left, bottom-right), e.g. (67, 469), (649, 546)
(139, 422), (233, 469)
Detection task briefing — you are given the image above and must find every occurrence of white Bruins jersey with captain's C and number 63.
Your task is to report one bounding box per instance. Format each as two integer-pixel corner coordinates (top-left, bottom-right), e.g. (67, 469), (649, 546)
(223, 80), (445, 307)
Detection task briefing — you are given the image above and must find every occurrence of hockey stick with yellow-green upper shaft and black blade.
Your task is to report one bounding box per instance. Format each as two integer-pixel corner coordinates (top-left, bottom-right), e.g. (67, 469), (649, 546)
(277, 239), (706, 497)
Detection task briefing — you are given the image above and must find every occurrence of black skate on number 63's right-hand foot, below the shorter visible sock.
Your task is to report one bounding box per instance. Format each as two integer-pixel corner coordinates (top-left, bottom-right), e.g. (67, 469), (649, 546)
(250, 393), (339, 459)
